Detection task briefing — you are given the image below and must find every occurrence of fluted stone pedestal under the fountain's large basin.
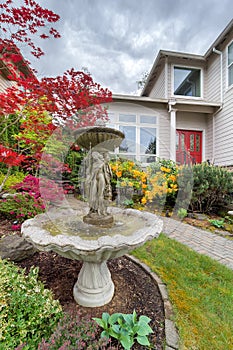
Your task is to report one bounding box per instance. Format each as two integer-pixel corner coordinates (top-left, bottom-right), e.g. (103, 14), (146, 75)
(73, 261), (114, 307)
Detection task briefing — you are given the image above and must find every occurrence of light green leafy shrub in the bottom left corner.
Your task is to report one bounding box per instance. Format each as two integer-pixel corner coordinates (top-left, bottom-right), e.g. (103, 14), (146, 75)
(0, 259), (62, 350)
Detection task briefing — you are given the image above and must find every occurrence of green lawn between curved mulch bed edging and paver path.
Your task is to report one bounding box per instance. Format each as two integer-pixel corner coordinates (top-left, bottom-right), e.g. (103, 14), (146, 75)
(133, 234), (233, 350)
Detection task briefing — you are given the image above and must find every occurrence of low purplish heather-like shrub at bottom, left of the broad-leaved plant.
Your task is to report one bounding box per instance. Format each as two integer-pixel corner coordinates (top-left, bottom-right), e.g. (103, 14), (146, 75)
(38, 314), (117, 350)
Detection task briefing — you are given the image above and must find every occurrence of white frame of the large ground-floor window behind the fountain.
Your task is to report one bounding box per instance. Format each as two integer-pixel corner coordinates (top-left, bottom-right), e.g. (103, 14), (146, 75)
(106, 110), (159, 166)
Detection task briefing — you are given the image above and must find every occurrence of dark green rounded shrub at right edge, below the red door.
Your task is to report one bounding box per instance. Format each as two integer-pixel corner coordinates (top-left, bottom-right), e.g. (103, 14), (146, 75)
(179, 163), (233, 213)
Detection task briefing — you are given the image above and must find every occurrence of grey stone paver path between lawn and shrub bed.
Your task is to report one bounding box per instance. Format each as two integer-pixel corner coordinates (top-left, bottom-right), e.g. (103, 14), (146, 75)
(162, 217), (233, 270)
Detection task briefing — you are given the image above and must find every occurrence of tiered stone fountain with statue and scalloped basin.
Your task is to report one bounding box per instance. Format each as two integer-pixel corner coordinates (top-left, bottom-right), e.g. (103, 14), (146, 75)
(22, 126), (162, 307)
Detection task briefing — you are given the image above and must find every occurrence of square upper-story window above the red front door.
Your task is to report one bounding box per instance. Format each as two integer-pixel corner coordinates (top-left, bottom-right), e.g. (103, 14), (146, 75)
(174, 66), (201, 97)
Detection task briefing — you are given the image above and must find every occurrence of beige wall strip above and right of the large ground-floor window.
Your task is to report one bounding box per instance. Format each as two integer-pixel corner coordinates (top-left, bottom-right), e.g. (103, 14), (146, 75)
(108, 102), (170, 159)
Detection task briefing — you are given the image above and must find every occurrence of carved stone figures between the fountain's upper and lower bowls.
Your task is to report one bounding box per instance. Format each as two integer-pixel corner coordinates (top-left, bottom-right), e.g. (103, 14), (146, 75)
(84, 150), (112, 224)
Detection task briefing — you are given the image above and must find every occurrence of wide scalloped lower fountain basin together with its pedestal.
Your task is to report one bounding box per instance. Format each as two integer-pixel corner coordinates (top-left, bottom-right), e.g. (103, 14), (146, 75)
(22, 207), (162, 307)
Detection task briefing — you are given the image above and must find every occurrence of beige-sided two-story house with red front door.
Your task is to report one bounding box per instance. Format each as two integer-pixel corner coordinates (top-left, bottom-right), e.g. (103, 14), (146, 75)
(106, 20), (233, 166)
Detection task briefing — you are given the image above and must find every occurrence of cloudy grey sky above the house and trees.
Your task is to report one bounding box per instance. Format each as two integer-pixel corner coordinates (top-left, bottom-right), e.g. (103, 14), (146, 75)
(30, 0), (232, 94)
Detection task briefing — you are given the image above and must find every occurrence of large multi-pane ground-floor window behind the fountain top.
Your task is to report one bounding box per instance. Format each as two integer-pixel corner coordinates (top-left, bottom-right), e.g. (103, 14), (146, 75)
(107, 113), (158, 163)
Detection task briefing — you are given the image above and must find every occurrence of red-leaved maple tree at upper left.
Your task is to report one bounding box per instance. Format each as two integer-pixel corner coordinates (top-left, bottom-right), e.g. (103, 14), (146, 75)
(0, 0), (111, 186)
